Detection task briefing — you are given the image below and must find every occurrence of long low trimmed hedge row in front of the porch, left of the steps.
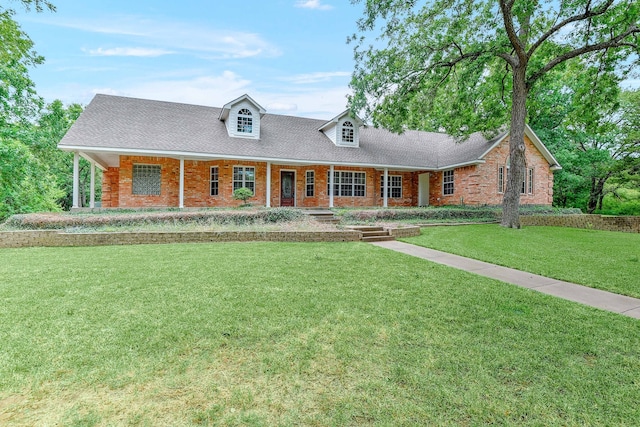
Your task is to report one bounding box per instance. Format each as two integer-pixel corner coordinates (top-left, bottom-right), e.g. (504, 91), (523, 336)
(5, 208), (305, 230)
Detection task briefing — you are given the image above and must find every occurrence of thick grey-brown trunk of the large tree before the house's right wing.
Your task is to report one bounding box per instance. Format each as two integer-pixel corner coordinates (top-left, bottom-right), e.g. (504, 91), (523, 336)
(500, 65), (528, 228)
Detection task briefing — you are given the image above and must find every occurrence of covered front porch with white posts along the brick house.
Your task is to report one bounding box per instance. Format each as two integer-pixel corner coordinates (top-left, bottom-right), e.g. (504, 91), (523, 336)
(73, 152), (439, 208)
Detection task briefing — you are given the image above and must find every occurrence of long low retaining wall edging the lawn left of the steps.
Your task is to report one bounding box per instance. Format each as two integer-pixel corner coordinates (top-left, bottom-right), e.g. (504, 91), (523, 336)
(0, 230), (361, 248)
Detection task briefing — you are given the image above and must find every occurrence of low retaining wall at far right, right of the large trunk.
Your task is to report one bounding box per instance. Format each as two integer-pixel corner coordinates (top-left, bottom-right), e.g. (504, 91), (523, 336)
(520, 215), (640, 233)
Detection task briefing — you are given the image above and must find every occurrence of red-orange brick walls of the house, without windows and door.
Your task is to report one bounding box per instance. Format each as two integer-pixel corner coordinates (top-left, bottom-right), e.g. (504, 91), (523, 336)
(102, 134), (553, 208)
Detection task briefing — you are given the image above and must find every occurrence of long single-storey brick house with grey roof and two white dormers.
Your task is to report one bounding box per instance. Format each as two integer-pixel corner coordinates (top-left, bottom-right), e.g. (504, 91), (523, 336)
(58, 95), (561, 208)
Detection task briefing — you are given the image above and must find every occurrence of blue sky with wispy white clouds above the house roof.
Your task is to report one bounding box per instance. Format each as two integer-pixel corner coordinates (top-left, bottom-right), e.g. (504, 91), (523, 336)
(15, 0), (362, 119)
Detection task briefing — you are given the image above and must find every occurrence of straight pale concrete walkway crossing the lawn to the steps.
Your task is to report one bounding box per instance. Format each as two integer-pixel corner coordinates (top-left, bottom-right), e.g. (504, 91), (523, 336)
(371, 241), (640, 319)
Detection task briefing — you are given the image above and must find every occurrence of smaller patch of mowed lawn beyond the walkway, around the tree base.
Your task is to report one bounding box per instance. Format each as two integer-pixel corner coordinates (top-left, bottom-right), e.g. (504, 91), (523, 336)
(402, 224), (640, 298)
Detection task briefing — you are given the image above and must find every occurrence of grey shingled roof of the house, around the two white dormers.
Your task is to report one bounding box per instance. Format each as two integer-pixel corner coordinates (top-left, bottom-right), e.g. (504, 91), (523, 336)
(58, 95), (504, 170)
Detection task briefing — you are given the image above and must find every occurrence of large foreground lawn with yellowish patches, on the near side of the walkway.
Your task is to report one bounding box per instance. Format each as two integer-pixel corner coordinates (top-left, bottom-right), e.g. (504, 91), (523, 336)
(0, 243), (640, 426)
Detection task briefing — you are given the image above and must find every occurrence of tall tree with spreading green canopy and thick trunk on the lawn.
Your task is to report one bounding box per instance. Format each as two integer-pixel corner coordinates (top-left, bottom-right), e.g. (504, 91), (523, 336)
(350, 0), (640, 228)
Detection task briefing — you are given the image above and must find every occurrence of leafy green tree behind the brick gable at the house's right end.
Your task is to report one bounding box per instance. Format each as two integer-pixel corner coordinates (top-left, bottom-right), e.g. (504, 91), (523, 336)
(529, 60), (640, 213)
